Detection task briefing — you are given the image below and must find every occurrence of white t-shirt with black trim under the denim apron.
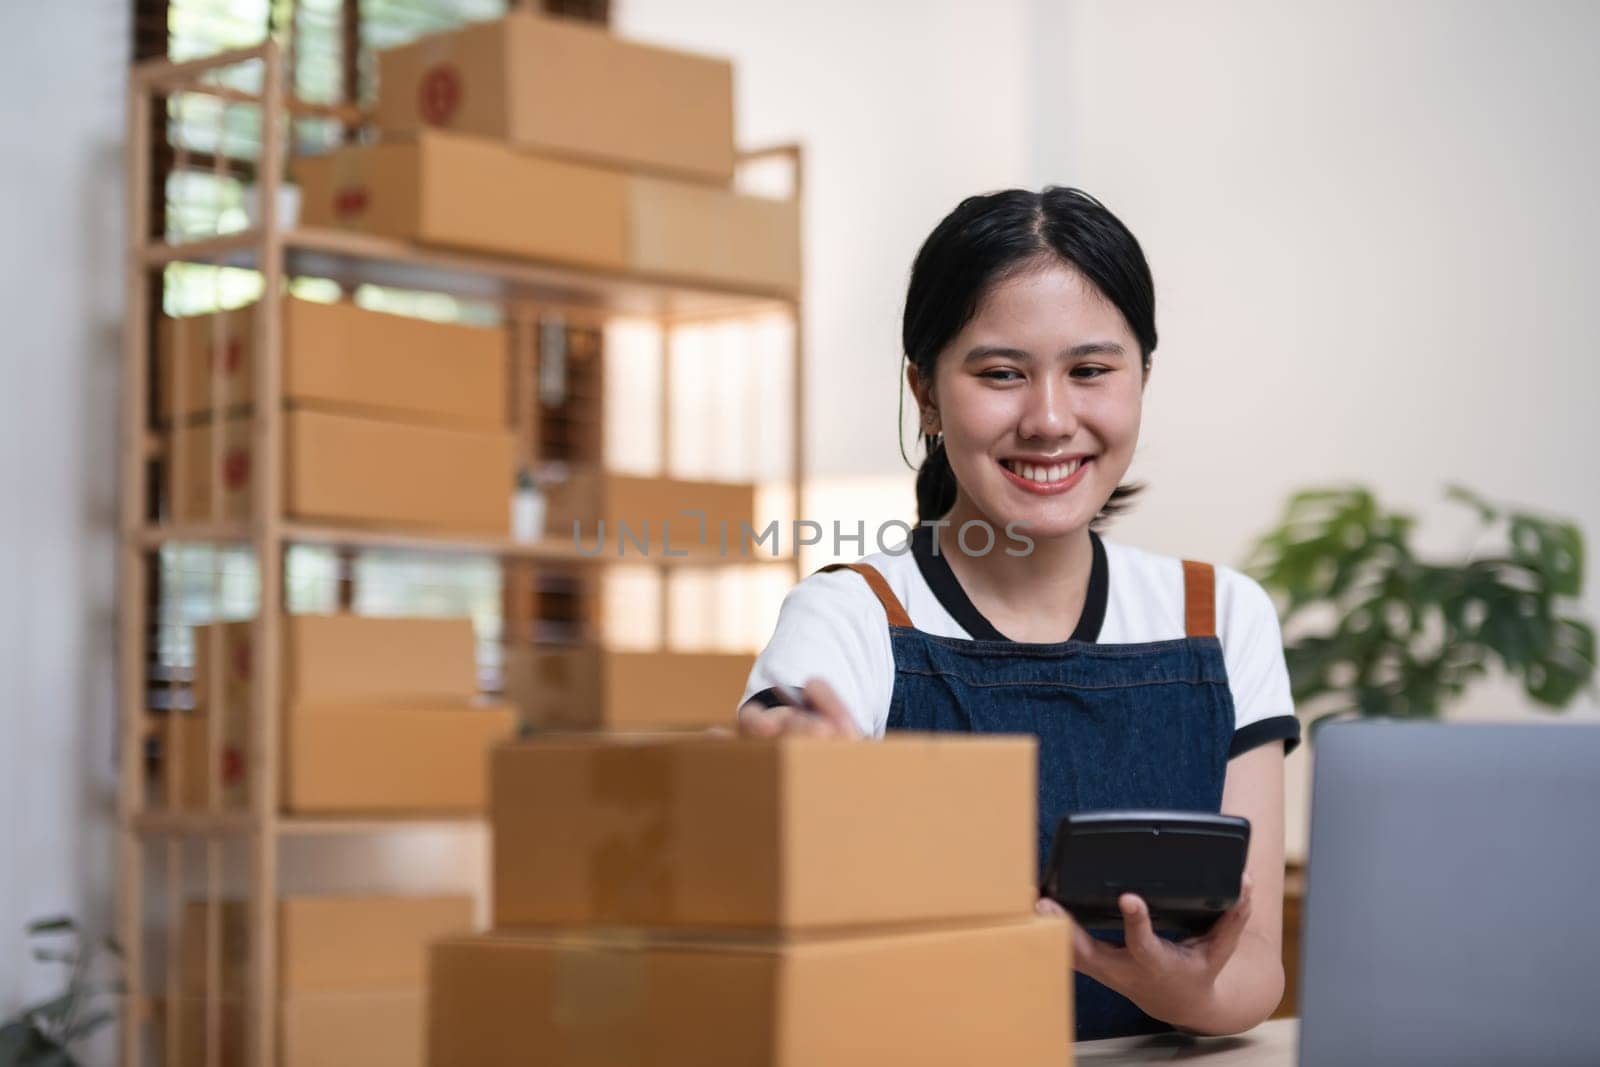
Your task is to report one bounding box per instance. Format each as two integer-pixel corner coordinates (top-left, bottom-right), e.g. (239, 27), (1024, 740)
(739, 526), (1299, 755)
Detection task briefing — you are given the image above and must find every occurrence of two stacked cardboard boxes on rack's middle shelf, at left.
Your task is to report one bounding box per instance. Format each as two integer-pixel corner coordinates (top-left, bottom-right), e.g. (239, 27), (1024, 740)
(158, 299), (514, 536)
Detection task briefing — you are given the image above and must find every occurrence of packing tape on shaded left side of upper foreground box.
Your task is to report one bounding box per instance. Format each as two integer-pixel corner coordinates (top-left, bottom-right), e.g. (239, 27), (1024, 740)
(589, 745), (678, 923)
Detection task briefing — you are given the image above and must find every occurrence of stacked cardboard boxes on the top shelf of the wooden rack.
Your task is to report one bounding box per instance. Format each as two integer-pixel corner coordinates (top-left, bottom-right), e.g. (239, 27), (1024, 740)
(294, 13), (800, 293)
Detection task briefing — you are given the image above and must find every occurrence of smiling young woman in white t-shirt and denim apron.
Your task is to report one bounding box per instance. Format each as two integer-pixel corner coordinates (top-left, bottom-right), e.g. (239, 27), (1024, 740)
(739, 189), (1299, 1040)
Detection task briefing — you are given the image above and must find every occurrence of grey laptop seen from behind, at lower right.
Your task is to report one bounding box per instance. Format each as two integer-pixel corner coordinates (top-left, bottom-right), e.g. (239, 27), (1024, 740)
(1299, 720), (1600, 1067)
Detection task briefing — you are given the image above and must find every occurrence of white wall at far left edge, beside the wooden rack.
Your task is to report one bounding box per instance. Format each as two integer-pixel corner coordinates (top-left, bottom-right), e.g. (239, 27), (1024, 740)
(0, 0), (130, 1036)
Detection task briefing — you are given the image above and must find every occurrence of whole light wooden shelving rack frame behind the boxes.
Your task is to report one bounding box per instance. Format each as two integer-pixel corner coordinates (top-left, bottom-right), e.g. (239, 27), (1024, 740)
(117, 35), (806, 1067)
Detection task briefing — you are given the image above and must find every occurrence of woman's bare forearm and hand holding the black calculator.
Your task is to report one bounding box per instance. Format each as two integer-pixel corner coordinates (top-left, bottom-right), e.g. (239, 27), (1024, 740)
(1040, 742), (1283, 1033)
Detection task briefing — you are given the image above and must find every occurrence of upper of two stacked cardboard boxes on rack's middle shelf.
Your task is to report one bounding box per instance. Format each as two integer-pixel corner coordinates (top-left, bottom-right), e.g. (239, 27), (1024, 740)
(157, 299), (507, 429)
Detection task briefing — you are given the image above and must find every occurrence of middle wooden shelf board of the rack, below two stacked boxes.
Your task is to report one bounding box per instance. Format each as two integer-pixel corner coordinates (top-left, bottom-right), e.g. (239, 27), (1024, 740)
(138, 522), (795, 566)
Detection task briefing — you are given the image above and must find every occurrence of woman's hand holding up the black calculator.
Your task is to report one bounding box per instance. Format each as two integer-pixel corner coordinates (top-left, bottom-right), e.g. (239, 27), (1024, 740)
(1035, 873), (1251, 1032)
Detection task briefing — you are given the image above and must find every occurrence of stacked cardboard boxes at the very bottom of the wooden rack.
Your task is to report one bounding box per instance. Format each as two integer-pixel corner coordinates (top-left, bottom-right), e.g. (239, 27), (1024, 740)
(168, 896), (474, 1067)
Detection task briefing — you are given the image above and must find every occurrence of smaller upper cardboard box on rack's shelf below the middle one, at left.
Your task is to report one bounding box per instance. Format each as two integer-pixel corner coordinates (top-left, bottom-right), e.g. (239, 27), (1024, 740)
(194, 614), (478, 709)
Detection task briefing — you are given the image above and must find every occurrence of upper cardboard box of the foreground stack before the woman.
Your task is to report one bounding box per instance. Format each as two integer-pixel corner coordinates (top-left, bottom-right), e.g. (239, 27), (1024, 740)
(491, 734), (1037, 929)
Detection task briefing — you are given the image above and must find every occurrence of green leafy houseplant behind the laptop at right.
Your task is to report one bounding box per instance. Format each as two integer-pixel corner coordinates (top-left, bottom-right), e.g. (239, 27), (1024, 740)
(1245, 486), (1595, 726)
